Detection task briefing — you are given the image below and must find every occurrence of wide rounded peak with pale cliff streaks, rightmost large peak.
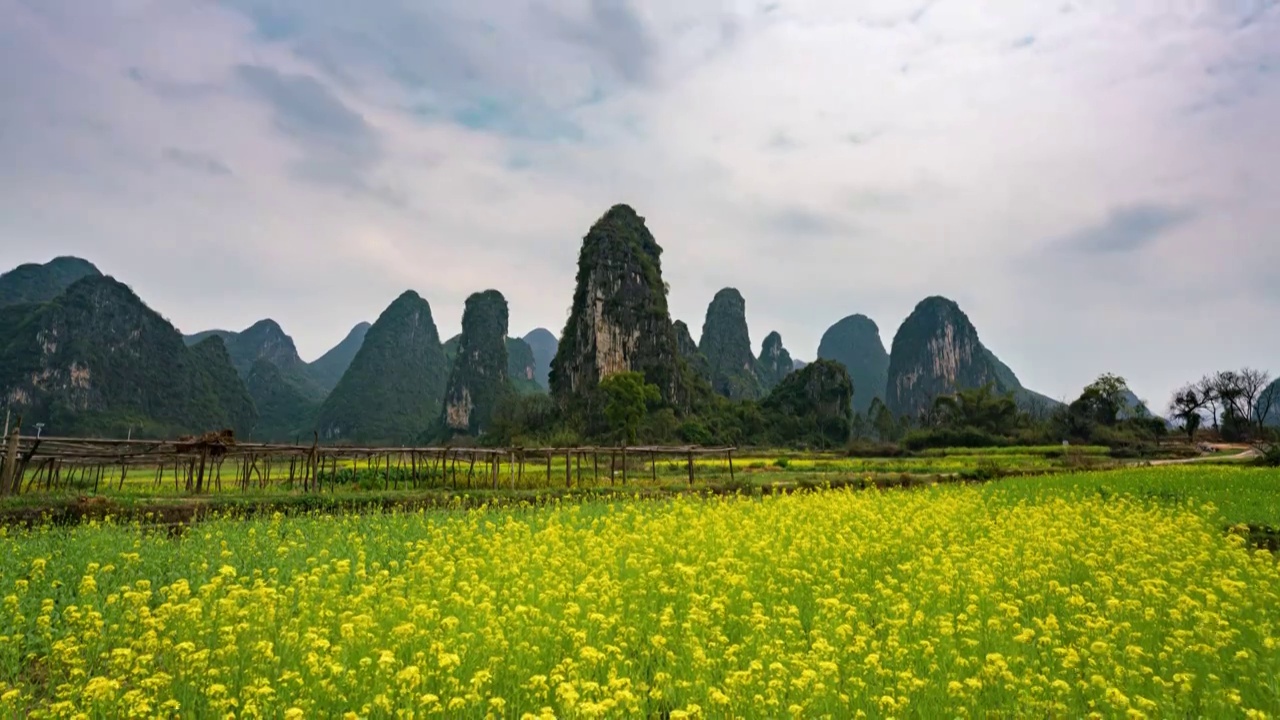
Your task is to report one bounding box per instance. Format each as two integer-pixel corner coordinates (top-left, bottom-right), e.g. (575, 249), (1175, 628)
(884, 296), (1005, 418)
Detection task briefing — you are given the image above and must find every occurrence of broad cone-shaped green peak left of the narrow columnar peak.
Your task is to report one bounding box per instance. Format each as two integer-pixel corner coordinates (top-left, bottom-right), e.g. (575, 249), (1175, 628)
(316, 291), (449, 443)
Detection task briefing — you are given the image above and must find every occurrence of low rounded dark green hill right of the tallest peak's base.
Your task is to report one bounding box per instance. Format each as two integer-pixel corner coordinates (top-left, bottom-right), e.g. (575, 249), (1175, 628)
(762, 360), (854, 447)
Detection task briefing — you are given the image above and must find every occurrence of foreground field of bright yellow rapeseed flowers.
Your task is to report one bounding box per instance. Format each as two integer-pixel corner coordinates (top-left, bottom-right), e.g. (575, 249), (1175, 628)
(0, 461), (1280, 717)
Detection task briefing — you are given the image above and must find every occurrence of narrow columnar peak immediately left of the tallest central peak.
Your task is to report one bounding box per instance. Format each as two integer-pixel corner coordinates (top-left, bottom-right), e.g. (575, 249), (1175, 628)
(443, 290), (509, 434)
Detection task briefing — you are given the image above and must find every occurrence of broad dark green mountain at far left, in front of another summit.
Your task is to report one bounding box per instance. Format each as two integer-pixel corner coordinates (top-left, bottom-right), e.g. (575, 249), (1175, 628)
(0, 275), (252, 437)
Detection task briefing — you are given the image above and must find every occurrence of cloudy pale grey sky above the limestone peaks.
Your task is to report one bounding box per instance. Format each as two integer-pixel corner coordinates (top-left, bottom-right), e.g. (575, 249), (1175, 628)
(0, 0), (1280, 409)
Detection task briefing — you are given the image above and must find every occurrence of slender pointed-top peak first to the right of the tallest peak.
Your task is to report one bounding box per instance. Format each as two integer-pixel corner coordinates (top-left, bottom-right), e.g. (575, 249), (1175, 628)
(698, 287), (763, 400)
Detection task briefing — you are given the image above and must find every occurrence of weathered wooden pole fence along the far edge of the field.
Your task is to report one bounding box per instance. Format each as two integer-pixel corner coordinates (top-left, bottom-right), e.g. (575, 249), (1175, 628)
(0, 429), (736, 496)
